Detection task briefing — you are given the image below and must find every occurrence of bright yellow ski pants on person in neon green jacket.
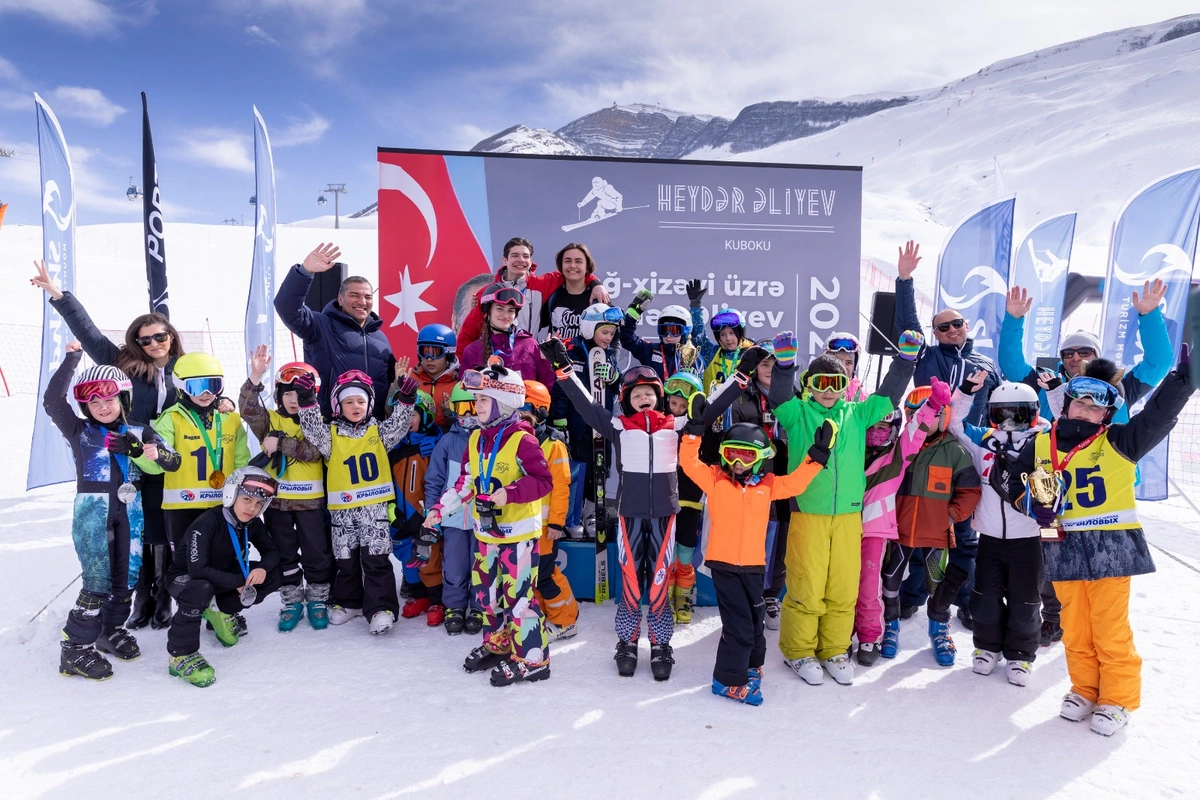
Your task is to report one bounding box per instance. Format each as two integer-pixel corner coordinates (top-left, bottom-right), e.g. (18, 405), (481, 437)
(779, 511), (863, 661)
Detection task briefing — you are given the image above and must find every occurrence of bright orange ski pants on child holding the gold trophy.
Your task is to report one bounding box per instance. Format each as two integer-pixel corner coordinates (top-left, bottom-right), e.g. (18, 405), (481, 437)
(1054, 577), (1141, 711)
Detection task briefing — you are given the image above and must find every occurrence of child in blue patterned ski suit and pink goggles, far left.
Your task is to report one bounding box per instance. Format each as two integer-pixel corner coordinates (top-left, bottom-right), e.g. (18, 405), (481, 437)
(42, 342), (178, 680)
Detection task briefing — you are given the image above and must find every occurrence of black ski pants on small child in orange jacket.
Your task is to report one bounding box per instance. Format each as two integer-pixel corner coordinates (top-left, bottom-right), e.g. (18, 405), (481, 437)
(710, 566), (767, 686)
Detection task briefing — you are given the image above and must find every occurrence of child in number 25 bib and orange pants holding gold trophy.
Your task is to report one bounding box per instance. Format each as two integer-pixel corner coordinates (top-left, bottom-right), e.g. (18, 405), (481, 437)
(1019, 344), (1195, 736)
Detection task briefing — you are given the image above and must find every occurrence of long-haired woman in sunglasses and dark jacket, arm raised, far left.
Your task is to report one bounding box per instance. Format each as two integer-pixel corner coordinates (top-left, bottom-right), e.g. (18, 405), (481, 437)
(30, 261), (184, 630)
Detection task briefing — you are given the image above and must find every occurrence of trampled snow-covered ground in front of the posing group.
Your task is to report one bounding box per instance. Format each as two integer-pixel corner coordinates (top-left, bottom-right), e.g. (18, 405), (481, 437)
(0, 388), (1200, 799)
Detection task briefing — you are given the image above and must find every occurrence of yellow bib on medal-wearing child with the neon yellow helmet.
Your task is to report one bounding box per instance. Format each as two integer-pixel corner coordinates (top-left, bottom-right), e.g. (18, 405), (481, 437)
(162, 407), (241, 509)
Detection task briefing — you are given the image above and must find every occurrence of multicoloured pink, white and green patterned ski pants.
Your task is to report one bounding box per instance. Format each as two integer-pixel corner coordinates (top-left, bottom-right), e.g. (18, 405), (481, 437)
(470, 539), (550, 664)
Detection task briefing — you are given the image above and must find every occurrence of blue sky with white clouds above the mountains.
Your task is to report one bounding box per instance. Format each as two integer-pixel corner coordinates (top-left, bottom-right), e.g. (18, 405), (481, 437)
(0, 0), (1194, 225)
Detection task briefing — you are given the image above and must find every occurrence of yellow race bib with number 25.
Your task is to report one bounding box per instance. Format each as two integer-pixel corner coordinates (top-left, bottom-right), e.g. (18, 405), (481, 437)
(1033, 432), (1141, 531)
